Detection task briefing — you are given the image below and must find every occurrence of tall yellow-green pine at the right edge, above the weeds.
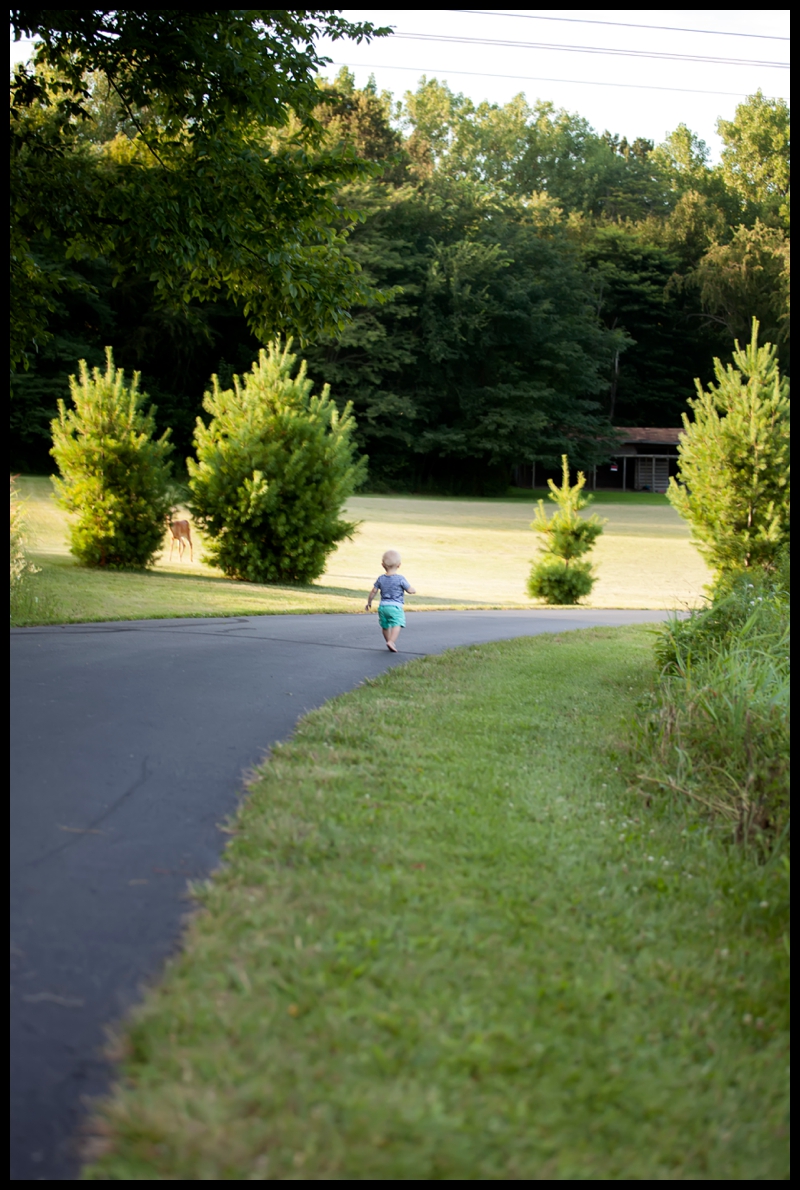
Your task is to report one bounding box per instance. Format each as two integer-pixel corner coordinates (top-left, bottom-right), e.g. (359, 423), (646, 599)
(668, 318), (789, 577)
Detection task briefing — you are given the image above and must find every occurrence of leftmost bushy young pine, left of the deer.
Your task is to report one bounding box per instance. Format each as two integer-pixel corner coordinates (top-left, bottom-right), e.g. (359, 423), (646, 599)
(50, 347), (173, 570)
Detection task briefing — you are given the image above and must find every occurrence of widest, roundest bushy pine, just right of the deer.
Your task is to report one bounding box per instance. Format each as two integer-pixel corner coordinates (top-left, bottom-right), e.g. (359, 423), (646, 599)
(187, 340), (367, 583)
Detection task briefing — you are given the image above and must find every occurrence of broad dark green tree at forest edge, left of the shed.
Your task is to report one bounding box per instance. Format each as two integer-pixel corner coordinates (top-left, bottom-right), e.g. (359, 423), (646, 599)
(303, 177), (613, 491)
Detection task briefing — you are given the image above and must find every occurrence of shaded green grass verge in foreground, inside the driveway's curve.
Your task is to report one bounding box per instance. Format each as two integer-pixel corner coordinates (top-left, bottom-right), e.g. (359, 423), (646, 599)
(83, 627), (788, 1180)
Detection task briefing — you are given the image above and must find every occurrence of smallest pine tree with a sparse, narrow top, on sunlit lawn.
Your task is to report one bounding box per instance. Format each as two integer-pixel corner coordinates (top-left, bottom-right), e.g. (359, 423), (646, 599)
(527, 455), (606, 603)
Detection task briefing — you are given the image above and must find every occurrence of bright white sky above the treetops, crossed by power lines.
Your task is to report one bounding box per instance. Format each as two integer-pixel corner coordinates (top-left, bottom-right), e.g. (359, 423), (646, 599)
(11, 8), (789, 162)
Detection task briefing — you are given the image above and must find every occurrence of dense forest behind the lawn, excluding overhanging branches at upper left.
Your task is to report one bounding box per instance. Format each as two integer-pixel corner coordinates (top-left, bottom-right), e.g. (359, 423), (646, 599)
(11, 47), (789, 491)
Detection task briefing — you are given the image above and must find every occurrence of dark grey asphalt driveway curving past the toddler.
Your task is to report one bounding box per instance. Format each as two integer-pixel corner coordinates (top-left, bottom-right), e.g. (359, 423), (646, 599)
(11, 609), (668, 1180)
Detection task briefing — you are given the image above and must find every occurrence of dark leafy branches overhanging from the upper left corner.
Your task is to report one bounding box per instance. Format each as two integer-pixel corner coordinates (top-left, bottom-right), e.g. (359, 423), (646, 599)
(11, 8), (390, 363)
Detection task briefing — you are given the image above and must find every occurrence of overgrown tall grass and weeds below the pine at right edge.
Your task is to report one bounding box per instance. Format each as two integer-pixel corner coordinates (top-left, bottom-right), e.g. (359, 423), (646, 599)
(639, 559), (790, 846)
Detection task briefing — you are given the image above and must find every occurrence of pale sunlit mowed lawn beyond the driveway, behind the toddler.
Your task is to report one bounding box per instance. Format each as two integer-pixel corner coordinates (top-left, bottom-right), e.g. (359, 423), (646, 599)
(17, 477), (711, 624)
